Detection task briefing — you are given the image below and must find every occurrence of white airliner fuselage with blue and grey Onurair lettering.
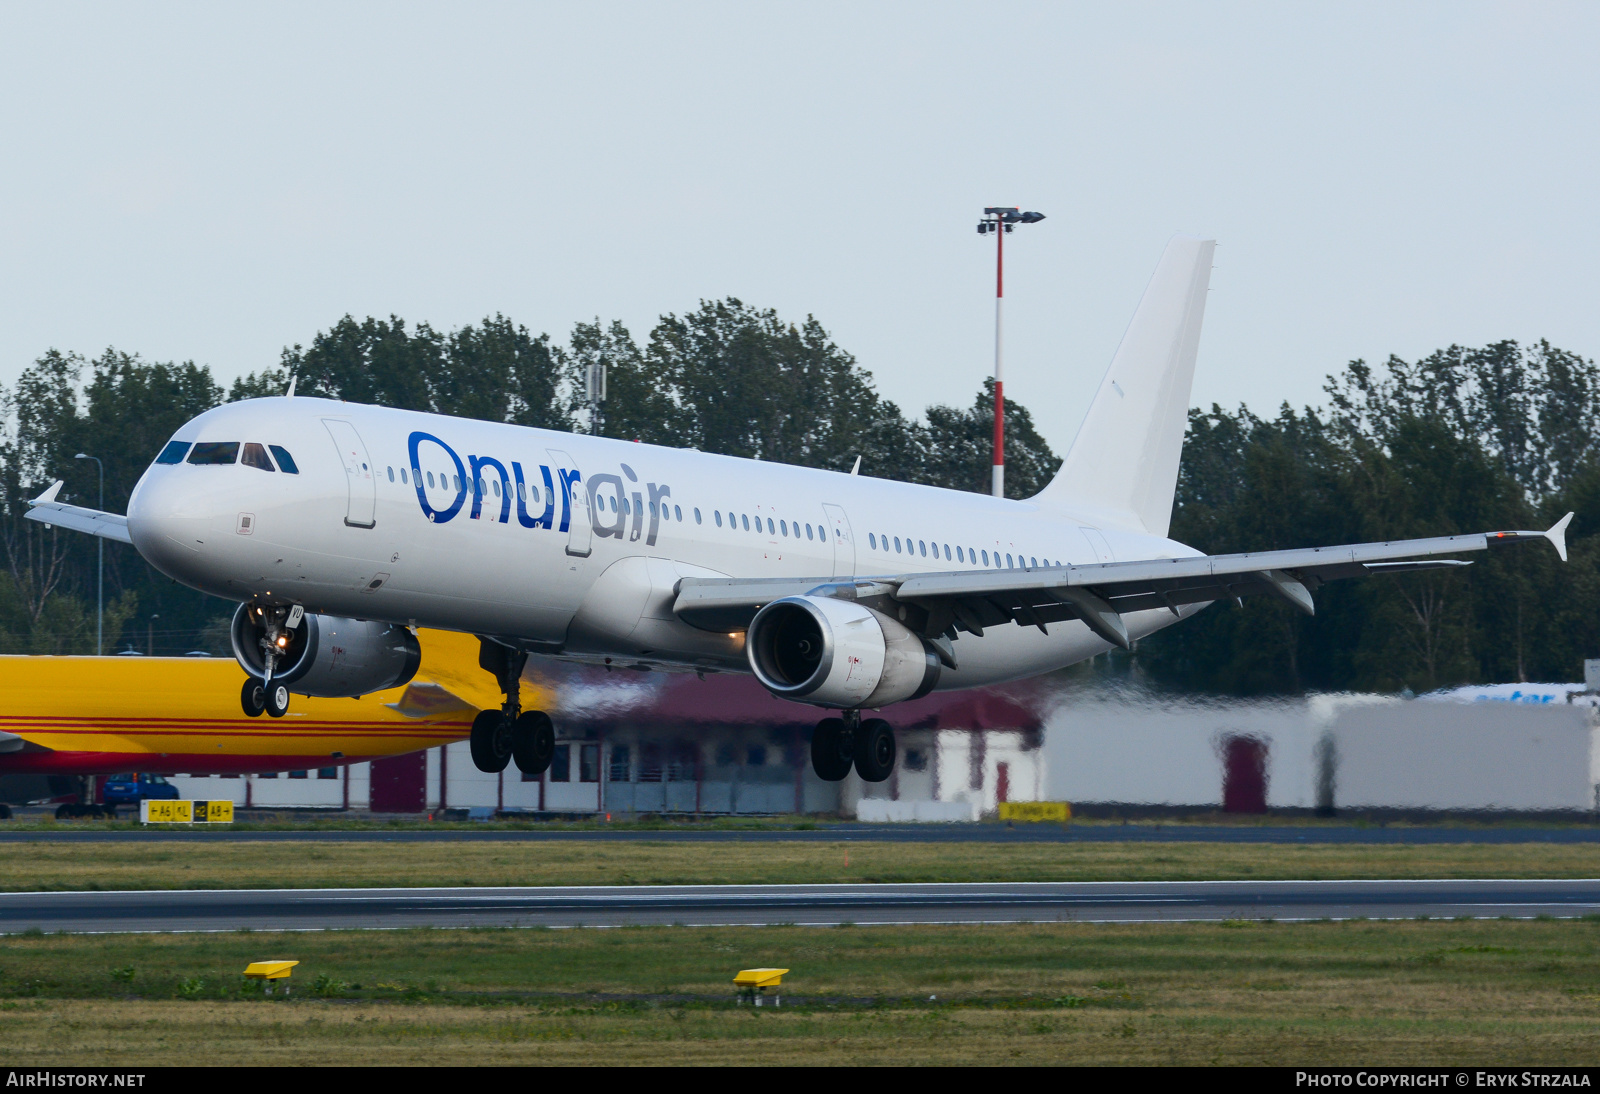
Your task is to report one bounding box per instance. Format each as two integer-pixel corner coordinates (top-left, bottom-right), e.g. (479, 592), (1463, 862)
(128, 398), (1198, 688)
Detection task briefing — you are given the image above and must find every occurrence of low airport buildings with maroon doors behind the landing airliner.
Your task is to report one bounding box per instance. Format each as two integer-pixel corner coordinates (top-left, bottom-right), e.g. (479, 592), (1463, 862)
(152, 670), (1600, 821)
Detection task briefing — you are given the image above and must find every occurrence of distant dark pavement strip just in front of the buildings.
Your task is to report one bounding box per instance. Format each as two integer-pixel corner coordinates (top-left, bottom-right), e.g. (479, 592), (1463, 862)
(0, 821), (1600, 844)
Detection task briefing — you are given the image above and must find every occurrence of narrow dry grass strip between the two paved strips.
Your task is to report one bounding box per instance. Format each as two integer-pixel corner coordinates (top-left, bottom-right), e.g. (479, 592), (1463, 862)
(0, 841), (1600, 892)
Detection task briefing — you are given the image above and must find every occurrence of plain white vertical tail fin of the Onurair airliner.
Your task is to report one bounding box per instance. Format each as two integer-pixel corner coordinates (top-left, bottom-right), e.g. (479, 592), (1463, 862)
(1034, 235), (1216, 536)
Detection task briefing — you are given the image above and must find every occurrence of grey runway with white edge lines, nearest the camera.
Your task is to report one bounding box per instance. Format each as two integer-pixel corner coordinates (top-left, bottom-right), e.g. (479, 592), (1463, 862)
(0, 880), (1600, 932)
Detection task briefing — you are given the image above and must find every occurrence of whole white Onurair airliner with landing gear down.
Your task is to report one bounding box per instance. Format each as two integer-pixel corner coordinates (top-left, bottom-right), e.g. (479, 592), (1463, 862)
(29, 237), (1571, 781)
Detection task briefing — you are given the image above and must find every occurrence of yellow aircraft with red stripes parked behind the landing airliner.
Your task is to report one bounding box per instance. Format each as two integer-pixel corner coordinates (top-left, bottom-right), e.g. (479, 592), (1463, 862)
(0, 630), (528, 776)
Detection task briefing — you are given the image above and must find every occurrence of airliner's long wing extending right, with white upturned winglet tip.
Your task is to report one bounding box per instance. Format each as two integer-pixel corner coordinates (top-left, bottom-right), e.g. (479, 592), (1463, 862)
(674, 513), (1573, 649)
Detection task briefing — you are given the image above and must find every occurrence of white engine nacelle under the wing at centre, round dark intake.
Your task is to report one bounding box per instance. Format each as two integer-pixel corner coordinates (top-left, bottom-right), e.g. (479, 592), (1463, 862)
(744, 597), (939, 710)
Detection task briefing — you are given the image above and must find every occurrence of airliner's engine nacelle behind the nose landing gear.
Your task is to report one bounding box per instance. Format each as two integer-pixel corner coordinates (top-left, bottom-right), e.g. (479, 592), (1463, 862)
(232, 605), (422, 699)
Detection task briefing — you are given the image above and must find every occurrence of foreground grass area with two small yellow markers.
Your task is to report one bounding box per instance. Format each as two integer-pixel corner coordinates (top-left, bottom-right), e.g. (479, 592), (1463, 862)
(0, 920), (1600, 1067)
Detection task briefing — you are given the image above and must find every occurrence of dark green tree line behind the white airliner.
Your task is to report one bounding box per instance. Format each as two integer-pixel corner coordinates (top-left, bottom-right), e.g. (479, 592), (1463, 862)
(0, 299), (1600, 696)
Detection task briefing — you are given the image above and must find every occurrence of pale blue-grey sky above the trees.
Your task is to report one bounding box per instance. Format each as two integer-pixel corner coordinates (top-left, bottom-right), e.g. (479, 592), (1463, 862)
(0, 0), (1600, 453)
